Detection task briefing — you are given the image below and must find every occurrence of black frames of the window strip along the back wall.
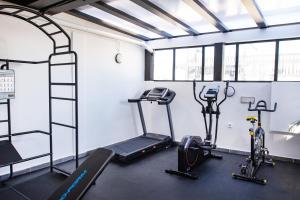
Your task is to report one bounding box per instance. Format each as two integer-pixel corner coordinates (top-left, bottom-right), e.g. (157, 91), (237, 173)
(152, 37), (300, 83)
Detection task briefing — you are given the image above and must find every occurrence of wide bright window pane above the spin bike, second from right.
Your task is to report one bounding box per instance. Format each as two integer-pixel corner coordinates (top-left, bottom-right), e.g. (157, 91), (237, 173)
(238, 42), (275, 81)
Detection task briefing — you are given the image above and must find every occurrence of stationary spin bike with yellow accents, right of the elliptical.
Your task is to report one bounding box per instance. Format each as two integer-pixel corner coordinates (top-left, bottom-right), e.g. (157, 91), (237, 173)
(232, 100), (277, 184)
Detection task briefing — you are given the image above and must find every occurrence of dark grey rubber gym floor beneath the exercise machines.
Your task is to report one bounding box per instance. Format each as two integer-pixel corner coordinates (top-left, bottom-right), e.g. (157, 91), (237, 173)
(0, 148), (300, 200)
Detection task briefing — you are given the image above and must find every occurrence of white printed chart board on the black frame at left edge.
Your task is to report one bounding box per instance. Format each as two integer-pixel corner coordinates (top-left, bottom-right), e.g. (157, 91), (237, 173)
(0, 70), (15, 100)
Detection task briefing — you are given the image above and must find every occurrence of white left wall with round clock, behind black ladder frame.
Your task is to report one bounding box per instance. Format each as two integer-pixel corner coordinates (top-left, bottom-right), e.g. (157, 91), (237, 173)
(0, 10), (144, 174)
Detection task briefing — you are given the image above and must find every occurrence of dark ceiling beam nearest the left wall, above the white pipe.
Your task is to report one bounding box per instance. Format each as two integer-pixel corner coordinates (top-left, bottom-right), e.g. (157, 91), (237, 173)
(66, 10), (150, 41)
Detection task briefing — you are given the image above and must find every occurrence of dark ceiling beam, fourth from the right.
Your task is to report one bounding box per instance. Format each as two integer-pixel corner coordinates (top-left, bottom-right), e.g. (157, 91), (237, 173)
(91, 2), (173, 38)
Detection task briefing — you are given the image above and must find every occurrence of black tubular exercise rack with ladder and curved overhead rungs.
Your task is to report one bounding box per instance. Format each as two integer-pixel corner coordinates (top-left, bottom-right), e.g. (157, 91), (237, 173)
(0, 5), (79, 182)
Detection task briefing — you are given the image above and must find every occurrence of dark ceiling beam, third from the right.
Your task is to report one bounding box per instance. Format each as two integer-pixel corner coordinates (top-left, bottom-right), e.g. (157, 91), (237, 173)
(130, 0), (199, 35)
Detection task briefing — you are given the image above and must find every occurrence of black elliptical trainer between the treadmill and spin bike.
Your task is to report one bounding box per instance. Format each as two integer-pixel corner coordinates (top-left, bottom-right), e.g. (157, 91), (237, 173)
(165, 81), (234, 179)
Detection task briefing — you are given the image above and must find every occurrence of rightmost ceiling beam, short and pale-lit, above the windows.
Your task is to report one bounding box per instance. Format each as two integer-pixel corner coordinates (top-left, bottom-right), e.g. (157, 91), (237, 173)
(242, 0), (272, 28)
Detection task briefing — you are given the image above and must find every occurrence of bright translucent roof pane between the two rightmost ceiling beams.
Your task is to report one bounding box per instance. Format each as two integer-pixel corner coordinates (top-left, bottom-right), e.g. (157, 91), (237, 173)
(202, 0), (255, 29)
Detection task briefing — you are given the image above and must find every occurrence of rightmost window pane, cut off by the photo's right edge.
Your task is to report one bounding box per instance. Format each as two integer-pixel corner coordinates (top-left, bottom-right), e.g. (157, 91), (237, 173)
(278, 40), (300, 81)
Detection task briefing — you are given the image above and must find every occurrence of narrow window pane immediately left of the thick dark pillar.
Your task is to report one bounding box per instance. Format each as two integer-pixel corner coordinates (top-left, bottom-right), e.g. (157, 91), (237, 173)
(204, 47), (215, 81)
